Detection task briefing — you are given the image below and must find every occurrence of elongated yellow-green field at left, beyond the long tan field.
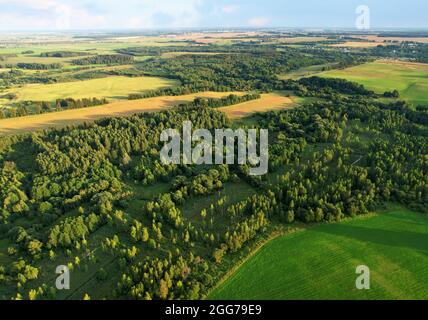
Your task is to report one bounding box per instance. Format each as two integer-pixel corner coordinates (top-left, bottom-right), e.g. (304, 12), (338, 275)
(0, 76), (178, 102)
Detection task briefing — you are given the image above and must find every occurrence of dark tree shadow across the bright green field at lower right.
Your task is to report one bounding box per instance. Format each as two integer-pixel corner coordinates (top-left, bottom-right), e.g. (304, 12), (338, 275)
(312, 224), (428, 255)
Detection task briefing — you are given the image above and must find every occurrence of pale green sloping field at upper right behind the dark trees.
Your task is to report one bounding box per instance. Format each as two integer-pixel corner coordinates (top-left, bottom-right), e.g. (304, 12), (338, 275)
(319, 61), (428, 106)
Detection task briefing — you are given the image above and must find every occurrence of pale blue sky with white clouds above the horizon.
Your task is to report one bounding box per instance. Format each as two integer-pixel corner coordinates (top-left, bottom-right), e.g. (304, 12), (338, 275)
(0, 0), (428, 31)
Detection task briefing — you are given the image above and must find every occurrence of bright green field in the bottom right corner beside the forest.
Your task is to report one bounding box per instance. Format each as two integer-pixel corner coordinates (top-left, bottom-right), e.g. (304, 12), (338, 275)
(209, 208), (428, 300)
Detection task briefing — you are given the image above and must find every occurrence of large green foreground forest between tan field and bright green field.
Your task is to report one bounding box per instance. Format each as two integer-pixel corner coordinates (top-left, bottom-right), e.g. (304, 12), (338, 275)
(0, 76), (428, 299)
